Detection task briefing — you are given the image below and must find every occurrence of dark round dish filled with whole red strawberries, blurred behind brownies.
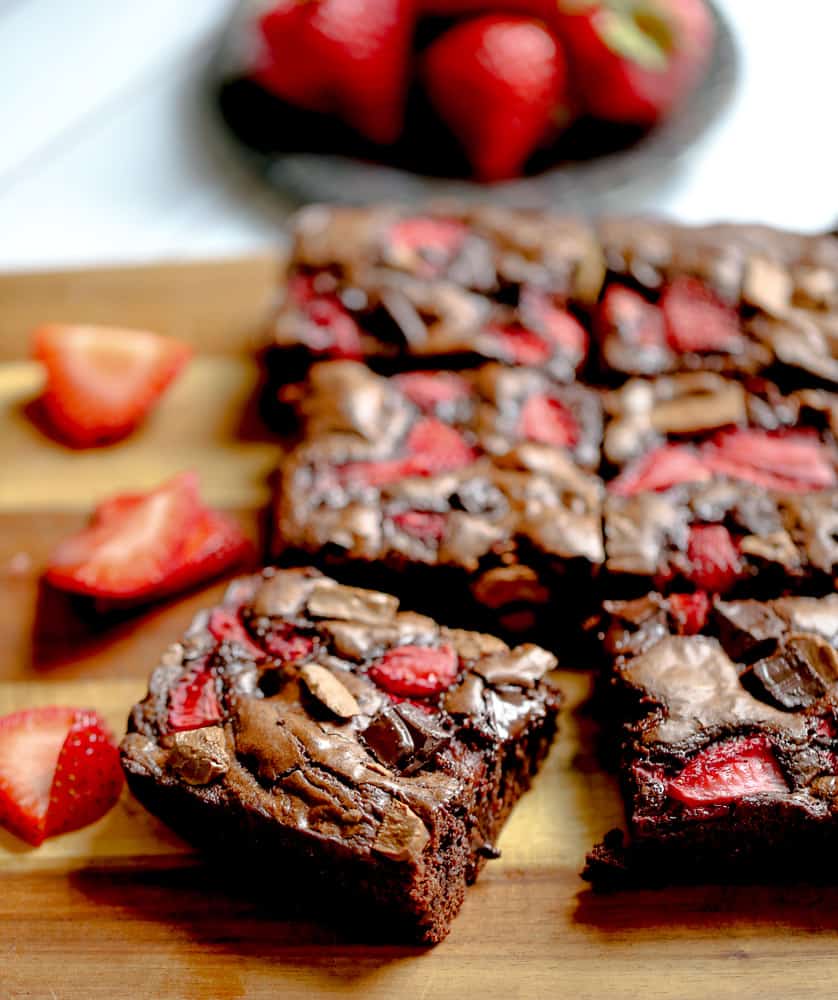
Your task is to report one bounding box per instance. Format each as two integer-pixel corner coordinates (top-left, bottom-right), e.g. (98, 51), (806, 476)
(213, 0), (736, 206)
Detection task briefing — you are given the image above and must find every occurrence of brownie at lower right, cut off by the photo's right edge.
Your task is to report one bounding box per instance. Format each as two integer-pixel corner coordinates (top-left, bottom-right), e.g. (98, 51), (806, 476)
(584, 594), (838, 887)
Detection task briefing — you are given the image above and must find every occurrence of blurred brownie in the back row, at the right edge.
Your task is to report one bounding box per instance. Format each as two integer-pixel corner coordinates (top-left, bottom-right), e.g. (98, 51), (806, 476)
(594, 219), (838, 385)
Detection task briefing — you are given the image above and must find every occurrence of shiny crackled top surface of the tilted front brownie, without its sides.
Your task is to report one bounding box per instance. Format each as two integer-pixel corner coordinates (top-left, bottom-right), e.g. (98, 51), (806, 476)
(122, 569), (559, 860)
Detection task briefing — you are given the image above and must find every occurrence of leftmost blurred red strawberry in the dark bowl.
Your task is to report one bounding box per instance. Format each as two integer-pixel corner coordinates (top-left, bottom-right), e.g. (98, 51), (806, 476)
(252, 0), (414, 145)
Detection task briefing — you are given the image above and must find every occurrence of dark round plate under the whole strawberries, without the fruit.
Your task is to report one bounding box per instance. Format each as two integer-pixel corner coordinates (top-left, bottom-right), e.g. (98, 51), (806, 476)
(210, 3), (738, 211)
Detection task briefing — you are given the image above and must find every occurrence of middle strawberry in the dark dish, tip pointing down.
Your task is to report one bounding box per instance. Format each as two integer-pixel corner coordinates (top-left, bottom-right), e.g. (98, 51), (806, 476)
(423, 14), (566, 181)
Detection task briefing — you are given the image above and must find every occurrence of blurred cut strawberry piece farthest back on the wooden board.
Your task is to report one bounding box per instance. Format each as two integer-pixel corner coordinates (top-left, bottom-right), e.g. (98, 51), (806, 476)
(33, 325), (192, 448)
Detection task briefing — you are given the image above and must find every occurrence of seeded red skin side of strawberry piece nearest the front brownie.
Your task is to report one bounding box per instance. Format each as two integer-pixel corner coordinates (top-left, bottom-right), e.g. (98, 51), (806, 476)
(46, 711), (124, 837)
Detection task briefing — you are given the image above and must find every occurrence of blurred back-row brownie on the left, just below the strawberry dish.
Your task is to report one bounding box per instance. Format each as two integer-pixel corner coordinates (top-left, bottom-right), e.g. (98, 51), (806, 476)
(271, 206), (604, 383)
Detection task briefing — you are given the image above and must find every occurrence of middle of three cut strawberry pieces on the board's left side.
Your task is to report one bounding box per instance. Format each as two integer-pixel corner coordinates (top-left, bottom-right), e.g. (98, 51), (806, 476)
(46, 473), (201, 601)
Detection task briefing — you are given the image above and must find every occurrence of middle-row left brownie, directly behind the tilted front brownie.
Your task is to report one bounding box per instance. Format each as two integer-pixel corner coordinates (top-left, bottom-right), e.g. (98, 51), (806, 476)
(275, 362), (603, 645)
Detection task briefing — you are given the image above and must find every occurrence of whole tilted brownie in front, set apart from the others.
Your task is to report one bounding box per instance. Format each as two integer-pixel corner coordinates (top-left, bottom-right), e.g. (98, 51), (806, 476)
(121, 568), (560, 943)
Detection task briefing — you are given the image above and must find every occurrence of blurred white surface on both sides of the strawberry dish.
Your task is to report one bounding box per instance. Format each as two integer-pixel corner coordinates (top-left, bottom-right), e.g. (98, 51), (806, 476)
(0, 0), (838, 268)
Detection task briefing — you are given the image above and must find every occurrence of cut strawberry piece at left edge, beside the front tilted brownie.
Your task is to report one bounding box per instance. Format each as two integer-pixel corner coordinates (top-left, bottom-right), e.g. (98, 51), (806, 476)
(0, 706), (122, 847)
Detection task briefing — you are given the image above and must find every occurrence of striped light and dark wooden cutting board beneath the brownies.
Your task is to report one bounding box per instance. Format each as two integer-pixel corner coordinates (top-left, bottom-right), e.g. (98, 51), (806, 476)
(0, 258), (838, 1000)
